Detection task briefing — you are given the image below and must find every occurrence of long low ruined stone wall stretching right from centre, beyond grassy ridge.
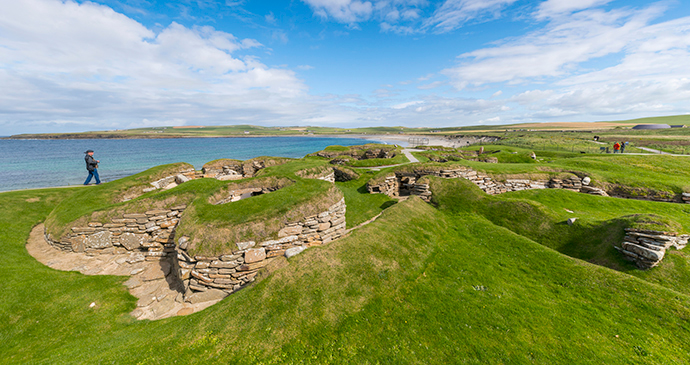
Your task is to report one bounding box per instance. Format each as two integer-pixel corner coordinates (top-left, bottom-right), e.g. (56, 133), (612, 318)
(367, 166), (608, 201)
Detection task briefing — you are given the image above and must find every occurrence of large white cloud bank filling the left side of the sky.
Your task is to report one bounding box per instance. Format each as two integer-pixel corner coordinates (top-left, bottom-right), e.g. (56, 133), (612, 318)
(0, 0), (309, 134)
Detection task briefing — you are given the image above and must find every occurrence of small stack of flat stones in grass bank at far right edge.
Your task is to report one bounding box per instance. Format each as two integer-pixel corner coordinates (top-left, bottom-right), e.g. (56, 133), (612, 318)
(614, 228), (689, 269)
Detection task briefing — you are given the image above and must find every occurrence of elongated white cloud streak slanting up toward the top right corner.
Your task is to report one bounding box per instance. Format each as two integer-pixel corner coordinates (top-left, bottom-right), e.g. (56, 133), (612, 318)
(443, 7), (660, 89)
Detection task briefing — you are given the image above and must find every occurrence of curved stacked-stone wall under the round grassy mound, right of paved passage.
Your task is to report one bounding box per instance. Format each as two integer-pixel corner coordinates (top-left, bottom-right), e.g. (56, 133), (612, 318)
(177, 199), (346, 302)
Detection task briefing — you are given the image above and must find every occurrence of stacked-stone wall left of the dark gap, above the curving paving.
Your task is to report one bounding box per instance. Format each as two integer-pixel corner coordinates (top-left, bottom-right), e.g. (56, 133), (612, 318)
(46, 205), (186, 261)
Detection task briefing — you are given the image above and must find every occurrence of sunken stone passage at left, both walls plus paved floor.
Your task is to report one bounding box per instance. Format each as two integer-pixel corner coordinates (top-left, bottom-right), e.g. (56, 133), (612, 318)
(37, 198), (347, 319)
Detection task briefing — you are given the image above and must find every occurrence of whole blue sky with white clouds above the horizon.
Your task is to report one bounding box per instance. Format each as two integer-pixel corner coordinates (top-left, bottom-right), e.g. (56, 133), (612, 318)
(0, 0), (690, 135)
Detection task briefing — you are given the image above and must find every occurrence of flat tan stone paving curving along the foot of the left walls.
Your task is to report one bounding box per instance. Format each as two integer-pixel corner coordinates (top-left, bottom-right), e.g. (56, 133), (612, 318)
(26, 224), (222, 320)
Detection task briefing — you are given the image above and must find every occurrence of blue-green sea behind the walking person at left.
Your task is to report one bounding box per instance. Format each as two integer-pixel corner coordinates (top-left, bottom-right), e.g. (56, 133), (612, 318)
(0, 137), (385, 191)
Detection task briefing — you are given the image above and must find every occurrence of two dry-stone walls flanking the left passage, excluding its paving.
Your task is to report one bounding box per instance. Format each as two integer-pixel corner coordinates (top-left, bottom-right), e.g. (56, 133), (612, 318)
(45, 198), (347, 304)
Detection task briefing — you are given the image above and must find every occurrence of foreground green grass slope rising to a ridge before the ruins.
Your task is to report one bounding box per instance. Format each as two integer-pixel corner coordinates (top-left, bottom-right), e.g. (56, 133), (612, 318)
(0, 186), (690, 364)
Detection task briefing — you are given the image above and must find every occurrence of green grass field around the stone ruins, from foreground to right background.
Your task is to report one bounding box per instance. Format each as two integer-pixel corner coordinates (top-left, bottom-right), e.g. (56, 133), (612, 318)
(0, 146), (690, 364)
